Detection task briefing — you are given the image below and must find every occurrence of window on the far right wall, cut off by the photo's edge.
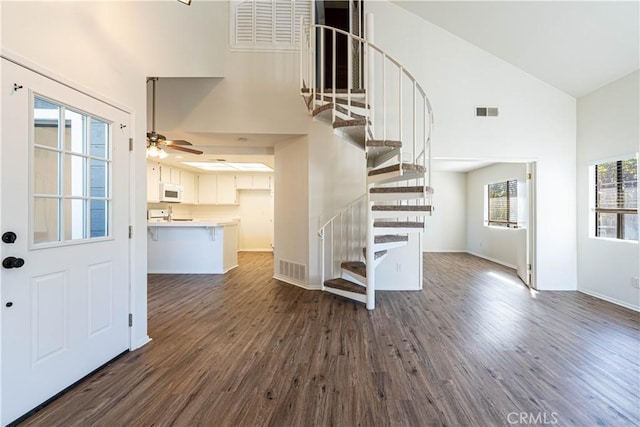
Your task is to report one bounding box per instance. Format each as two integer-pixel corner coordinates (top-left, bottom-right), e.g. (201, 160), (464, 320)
(593, 158), (638, 240)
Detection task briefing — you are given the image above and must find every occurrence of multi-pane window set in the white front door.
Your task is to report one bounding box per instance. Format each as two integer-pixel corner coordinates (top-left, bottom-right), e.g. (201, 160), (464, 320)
(30, 96), (111, 245)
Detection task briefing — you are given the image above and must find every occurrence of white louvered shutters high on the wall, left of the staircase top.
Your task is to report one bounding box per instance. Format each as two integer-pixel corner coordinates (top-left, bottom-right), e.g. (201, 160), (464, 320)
(230, 0), (311, 51)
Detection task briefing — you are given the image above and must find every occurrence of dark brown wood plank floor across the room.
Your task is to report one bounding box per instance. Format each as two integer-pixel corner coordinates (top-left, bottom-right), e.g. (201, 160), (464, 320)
(17, 253), (640, 427)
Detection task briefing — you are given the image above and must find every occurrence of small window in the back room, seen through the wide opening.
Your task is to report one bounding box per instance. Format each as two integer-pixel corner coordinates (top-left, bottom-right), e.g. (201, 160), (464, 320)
(487, 180), (518, 228)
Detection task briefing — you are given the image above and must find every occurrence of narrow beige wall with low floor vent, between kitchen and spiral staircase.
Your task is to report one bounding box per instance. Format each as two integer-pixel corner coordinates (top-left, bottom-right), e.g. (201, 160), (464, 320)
(273, 136), (309, 287)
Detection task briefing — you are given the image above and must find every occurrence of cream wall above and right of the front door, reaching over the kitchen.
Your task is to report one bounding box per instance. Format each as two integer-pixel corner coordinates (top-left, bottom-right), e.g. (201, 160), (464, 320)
(0, 1), (228, 348)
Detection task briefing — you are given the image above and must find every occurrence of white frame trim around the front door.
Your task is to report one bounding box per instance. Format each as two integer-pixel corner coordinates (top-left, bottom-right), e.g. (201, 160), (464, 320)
(0, 49), (139, 424)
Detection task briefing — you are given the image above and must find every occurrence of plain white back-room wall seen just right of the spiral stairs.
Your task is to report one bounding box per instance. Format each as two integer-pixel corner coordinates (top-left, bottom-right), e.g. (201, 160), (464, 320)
(422, 171), (467, 252)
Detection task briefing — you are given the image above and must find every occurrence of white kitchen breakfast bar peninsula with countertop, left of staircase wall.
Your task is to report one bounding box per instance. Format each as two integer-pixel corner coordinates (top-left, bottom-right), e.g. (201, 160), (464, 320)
(147, 220), (238, 274)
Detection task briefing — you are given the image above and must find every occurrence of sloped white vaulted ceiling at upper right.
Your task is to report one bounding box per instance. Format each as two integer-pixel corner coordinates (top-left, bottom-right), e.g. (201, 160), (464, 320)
(394, 0), (640, 98)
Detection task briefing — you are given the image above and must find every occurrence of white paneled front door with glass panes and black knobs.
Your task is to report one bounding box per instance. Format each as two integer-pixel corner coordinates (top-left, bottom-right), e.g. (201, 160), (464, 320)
(0, 59), (130, 425)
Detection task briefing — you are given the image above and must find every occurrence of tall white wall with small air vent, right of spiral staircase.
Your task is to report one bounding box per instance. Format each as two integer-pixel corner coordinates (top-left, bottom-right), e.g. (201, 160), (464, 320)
(366, 1), (577, 290)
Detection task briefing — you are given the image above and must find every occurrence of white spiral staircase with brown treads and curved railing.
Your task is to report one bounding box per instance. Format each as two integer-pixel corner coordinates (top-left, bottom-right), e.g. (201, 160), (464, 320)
(300, 18), (433, 310)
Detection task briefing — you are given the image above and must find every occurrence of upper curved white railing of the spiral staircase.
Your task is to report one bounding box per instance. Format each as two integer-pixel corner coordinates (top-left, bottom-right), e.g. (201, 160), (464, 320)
(300, 24), (433, 181)
